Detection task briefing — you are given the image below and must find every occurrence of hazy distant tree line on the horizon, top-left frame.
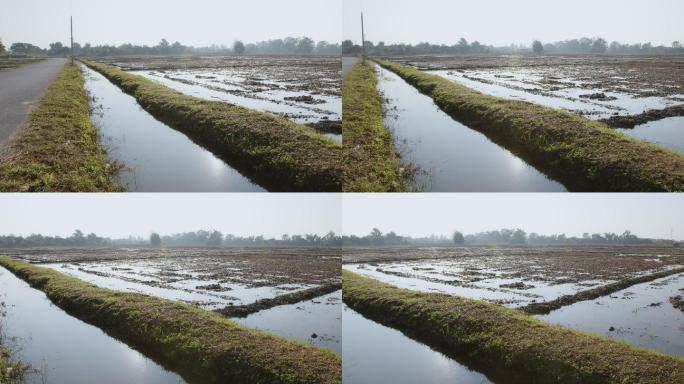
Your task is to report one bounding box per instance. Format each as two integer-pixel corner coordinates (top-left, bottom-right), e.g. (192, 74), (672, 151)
(0, 37), (342, 57)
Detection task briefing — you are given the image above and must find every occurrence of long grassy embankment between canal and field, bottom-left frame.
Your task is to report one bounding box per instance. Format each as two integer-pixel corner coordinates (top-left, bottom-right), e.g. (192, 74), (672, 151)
(0, 257), (342, 383)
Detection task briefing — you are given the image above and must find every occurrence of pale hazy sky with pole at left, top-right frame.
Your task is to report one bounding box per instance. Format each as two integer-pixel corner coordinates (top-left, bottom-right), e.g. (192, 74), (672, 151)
(343, 0), (684, 46)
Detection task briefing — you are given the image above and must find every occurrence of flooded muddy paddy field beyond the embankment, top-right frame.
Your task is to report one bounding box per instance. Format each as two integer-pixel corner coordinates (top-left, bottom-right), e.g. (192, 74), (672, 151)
(391, 55), (684, 151)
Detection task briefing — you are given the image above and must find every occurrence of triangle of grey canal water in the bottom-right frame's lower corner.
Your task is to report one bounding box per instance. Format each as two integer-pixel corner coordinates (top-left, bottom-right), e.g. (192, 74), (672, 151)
(342, 305), (491, 384)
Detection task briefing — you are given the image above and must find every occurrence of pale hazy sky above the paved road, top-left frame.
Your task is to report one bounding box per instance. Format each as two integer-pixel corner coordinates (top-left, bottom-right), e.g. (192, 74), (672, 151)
(0, 0), (342, 48)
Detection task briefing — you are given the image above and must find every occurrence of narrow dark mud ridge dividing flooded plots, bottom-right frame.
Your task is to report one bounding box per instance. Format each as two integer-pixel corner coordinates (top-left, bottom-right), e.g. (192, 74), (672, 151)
(519, 268), (684, 315)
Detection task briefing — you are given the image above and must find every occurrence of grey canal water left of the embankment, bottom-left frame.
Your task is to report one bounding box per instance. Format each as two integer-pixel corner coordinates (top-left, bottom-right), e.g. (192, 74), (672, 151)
(0, 267), (184, 384)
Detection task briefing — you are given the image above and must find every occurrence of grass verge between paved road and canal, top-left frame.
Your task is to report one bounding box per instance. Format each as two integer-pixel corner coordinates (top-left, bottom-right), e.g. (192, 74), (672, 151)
(0, 64), (120, 192)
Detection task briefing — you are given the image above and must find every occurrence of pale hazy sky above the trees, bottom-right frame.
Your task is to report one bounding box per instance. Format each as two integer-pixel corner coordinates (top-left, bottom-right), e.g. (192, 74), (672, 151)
(342, 193), (684, 240)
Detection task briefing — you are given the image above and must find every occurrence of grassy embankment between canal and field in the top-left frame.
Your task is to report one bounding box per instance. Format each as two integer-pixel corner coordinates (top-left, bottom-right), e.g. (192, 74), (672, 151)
(84, 61), (342, 191)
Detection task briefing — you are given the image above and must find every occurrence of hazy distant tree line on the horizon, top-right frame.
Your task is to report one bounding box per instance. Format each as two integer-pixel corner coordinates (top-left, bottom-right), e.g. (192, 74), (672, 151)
(342, 37), (684, 56)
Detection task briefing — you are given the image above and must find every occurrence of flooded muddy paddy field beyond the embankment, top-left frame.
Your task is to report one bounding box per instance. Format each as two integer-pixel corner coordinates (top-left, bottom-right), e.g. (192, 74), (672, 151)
(92, 56), (342, 141)
